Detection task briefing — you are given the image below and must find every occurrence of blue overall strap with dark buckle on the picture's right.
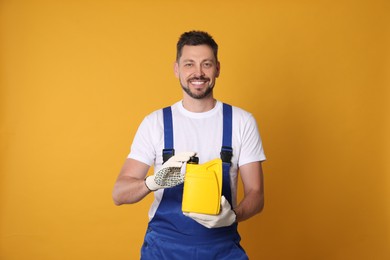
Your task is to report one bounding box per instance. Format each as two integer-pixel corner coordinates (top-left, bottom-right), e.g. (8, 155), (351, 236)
(221, 103), (233, 206)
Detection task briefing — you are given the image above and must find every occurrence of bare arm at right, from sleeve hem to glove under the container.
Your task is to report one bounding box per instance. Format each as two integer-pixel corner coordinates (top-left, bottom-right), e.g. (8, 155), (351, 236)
(234, 162), (264, 222)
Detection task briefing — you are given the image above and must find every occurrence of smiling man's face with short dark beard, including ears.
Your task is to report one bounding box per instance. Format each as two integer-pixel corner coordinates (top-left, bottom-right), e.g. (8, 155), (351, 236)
(175, 45), (220, 99)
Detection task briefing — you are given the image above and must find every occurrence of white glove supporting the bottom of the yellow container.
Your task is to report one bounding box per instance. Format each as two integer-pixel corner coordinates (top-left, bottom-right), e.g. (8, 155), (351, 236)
(183, 196), (237, 228)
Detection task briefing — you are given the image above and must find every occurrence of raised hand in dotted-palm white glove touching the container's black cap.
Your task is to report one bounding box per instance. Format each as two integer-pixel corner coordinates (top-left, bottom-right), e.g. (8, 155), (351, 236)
(145, 152), (195, 191)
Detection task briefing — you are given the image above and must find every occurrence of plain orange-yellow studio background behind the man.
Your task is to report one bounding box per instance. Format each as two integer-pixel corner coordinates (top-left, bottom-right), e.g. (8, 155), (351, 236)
(0, 0), (390, 260)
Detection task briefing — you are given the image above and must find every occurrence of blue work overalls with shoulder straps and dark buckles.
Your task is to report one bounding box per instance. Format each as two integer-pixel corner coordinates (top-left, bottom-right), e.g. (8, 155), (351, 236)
(141, 104), (248, 260)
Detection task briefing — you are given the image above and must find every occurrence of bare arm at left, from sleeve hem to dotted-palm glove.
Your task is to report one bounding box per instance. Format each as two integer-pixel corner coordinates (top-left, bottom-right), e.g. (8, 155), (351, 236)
(112, 159), (150, 206)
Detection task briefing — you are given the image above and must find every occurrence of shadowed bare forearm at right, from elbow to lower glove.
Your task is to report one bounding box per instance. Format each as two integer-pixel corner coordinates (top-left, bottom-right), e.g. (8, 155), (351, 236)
(234, 191), (264, 222)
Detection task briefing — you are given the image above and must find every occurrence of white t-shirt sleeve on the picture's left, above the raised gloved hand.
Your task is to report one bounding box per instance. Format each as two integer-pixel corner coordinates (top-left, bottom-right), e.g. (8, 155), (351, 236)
(127, 115), (156, 166)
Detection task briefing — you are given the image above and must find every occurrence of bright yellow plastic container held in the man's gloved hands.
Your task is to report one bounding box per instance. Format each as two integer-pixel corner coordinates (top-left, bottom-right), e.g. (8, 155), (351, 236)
(182, 159), (222, 215)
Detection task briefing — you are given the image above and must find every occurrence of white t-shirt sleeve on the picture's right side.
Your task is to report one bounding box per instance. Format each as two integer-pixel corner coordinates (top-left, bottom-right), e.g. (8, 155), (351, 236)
(238, 114), (266, 166)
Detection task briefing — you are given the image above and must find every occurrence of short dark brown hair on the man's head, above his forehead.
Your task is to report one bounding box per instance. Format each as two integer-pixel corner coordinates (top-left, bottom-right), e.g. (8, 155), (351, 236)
(176, 31), (218, 61)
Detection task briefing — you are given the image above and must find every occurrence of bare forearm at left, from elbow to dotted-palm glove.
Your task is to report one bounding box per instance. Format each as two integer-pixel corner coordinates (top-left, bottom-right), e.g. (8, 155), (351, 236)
(112, 176), (150, 206)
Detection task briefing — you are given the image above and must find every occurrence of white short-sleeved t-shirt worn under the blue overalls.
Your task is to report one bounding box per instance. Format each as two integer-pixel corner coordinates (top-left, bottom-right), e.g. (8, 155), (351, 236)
(128, 101), (266, 219)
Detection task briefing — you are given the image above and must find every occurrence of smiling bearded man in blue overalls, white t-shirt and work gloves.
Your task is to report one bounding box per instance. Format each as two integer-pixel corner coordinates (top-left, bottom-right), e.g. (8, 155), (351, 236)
(113, 31), (265, 260)
